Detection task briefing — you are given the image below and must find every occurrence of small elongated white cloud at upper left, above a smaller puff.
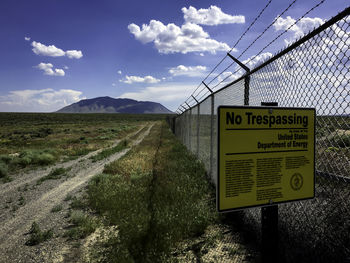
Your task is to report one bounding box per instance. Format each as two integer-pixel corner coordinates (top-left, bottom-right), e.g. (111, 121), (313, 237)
(32, 41), (83, 59)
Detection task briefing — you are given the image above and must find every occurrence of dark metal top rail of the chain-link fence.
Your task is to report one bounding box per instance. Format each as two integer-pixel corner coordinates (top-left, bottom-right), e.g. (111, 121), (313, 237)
(179, 6), (350, 116)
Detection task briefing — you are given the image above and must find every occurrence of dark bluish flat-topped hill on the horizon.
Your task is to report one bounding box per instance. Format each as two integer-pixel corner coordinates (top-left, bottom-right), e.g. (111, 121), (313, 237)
(57, 97), (173, 114)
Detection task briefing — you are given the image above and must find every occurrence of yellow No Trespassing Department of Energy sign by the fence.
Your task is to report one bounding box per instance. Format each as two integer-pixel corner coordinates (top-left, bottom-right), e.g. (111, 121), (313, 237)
(217, 106), (315, 212)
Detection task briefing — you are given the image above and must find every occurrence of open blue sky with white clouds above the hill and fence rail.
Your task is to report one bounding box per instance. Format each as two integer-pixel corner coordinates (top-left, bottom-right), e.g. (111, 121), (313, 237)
(0, 0), (349, 112)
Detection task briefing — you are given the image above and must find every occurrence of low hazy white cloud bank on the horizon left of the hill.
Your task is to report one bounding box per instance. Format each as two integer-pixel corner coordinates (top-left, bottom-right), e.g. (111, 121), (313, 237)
(0, 89), (85, 112)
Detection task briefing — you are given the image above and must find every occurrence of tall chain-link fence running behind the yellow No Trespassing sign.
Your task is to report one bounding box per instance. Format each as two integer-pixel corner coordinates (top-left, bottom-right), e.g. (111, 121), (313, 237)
(174, 8), (350, 262)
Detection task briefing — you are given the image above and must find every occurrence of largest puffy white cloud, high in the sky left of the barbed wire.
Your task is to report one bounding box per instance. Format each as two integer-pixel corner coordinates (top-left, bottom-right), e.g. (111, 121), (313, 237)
(128, 20), (231, 54)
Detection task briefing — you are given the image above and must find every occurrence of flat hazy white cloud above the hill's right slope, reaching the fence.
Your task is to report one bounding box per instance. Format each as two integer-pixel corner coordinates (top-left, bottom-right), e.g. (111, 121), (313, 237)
(119, 83), (194, 110)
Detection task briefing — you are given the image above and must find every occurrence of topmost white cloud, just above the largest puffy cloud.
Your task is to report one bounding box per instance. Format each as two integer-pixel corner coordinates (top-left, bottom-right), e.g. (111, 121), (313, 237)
(181, 5), (245, 26)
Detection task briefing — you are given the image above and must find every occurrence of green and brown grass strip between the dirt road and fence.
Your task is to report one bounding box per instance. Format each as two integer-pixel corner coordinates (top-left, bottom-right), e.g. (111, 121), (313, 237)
(88, 123), (216, 262)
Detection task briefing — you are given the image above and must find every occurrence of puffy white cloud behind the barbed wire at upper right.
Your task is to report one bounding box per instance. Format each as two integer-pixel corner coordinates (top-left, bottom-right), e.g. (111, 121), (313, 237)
(273, 16), (324, 45)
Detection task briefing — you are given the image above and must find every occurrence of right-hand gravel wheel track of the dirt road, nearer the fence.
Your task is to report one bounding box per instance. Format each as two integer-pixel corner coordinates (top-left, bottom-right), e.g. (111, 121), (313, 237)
(0, 124), (154, 262)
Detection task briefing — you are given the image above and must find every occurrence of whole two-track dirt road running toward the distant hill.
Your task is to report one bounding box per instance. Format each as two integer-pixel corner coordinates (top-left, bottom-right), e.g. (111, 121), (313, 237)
(0, 124), (152, 263)
